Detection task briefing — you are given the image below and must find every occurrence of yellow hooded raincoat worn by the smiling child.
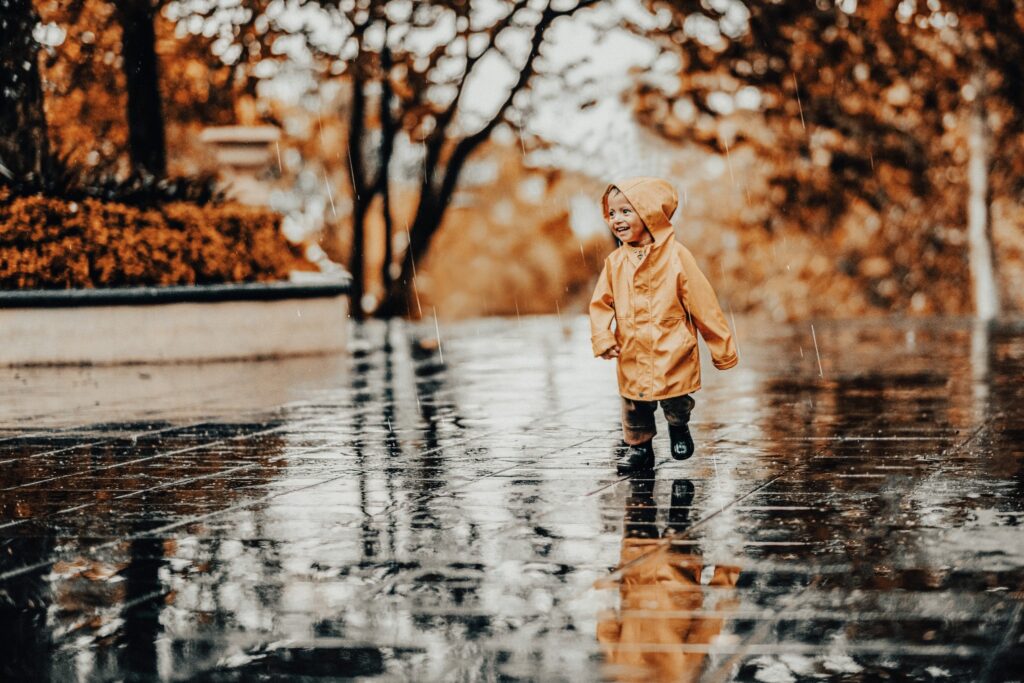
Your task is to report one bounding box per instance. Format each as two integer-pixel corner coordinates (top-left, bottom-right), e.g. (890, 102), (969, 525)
(590, 177), (739, 400)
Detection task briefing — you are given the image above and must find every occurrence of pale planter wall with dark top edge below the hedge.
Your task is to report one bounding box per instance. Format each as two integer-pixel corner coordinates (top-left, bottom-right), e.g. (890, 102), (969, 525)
(0, 283), (348, 366)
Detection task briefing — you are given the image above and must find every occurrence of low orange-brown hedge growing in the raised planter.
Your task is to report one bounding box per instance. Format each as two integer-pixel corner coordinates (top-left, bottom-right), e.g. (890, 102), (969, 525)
(0, 186), (313, 290)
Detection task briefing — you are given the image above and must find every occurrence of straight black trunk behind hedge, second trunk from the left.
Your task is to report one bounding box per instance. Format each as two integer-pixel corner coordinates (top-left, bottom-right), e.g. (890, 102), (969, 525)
(118, 0), (167, 177)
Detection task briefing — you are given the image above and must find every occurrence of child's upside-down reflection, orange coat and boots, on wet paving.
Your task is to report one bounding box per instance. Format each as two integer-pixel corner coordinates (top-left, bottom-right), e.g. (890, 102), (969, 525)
(597, 479), (739, 681)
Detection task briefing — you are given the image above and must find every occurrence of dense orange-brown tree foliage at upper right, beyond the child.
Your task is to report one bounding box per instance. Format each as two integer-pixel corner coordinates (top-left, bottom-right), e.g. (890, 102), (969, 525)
(634, 0), (1022, 311)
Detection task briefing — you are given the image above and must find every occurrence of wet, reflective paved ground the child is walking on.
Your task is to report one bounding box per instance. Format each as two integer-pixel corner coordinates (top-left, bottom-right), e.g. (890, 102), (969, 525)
(0, 317), (1024, 683)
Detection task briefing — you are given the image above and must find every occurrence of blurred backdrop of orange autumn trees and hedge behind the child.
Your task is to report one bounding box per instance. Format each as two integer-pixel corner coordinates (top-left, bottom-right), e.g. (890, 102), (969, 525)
(0, 0), (1024, 321)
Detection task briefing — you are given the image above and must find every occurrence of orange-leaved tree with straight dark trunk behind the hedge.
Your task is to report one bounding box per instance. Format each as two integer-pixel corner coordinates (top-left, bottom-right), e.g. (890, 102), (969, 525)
(40, 0), (238, 178)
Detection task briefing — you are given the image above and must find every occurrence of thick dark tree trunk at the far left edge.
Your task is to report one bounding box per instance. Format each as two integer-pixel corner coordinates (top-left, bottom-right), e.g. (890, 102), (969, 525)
(0, 0), (49, 180)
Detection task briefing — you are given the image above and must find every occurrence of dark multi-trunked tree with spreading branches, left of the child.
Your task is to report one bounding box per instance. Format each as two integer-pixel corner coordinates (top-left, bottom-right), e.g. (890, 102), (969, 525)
(323, 0), (595, 316)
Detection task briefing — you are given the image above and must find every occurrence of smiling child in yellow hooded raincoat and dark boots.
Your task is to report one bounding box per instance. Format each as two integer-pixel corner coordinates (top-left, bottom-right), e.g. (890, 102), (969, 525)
(590, 178), (739, 472)
